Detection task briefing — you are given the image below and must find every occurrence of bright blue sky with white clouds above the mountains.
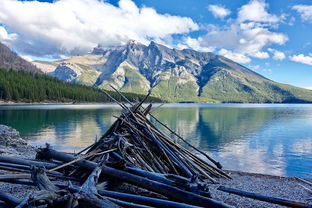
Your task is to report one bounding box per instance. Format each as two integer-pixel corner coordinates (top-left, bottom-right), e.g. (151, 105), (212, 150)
(0, 0), (312, 89)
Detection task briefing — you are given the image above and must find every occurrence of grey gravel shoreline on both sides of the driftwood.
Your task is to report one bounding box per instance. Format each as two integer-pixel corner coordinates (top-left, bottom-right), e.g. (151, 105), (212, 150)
(0, 144), (312, 208)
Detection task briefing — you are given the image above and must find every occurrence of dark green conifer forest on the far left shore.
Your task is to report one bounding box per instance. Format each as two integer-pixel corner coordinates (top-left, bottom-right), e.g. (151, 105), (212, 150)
(0, 70), (161, 102)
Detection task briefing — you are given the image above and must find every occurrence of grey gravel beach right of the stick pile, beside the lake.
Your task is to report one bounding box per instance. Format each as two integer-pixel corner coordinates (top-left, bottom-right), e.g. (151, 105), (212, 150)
(210, 171), (312, 208)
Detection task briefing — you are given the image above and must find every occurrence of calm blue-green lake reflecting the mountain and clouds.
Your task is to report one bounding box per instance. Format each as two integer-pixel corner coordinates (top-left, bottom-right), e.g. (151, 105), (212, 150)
(0, 104), (312, 178)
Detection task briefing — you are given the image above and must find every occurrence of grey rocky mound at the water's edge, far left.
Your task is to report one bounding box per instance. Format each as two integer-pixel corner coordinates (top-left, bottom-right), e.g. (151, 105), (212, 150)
(0, 125), (27, 147)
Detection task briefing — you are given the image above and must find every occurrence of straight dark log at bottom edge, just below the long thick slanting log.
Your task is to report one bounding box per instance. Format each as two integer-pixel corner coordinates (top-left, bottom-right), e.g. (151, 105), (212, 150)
(98, 190), (202, 208)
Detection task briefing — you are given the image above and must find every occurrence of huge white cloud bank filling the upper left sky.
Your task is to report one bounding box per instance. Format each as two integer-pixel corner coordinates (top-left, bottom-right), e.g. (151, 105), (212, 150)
(0, 0), (199, 55)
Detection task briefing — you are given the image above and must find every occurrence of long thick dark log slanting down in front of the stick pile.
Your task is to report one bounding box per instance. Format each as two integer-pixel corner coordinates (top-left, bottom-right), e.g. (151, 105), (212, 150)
(38, 148), (230, 208)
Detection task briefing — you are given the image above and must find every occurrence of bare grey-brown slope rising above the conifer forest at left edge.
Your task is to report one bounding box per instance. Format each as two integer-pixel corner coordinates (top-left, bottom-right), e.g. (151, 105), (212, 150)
(0, 42), (41, 73)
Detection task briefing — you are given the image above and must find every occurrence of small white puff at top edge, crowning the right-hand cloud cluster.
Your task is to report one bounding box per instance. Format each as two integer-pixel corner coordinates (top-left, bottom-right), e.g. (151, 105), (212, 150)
(238, 0), (280, 23)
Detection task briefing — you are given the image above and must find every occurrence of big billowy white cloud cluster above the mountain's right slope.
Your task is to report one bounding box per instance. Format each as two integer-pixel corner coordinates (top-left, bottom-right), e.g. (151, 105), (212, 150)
(195, 0), (288, 63)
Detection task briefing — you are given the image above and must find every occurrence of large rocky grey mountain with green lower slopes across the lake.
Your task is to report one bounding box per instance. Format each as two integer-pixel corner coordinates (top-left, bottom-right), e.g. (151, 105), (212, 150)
(34, 40), (312, 103)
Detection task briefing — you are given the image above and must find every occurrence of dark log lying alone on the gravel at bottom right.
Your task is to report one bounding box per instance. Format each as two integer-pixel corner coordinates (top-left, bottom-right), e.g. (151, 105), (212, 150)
(218, 186), (312, 208)
